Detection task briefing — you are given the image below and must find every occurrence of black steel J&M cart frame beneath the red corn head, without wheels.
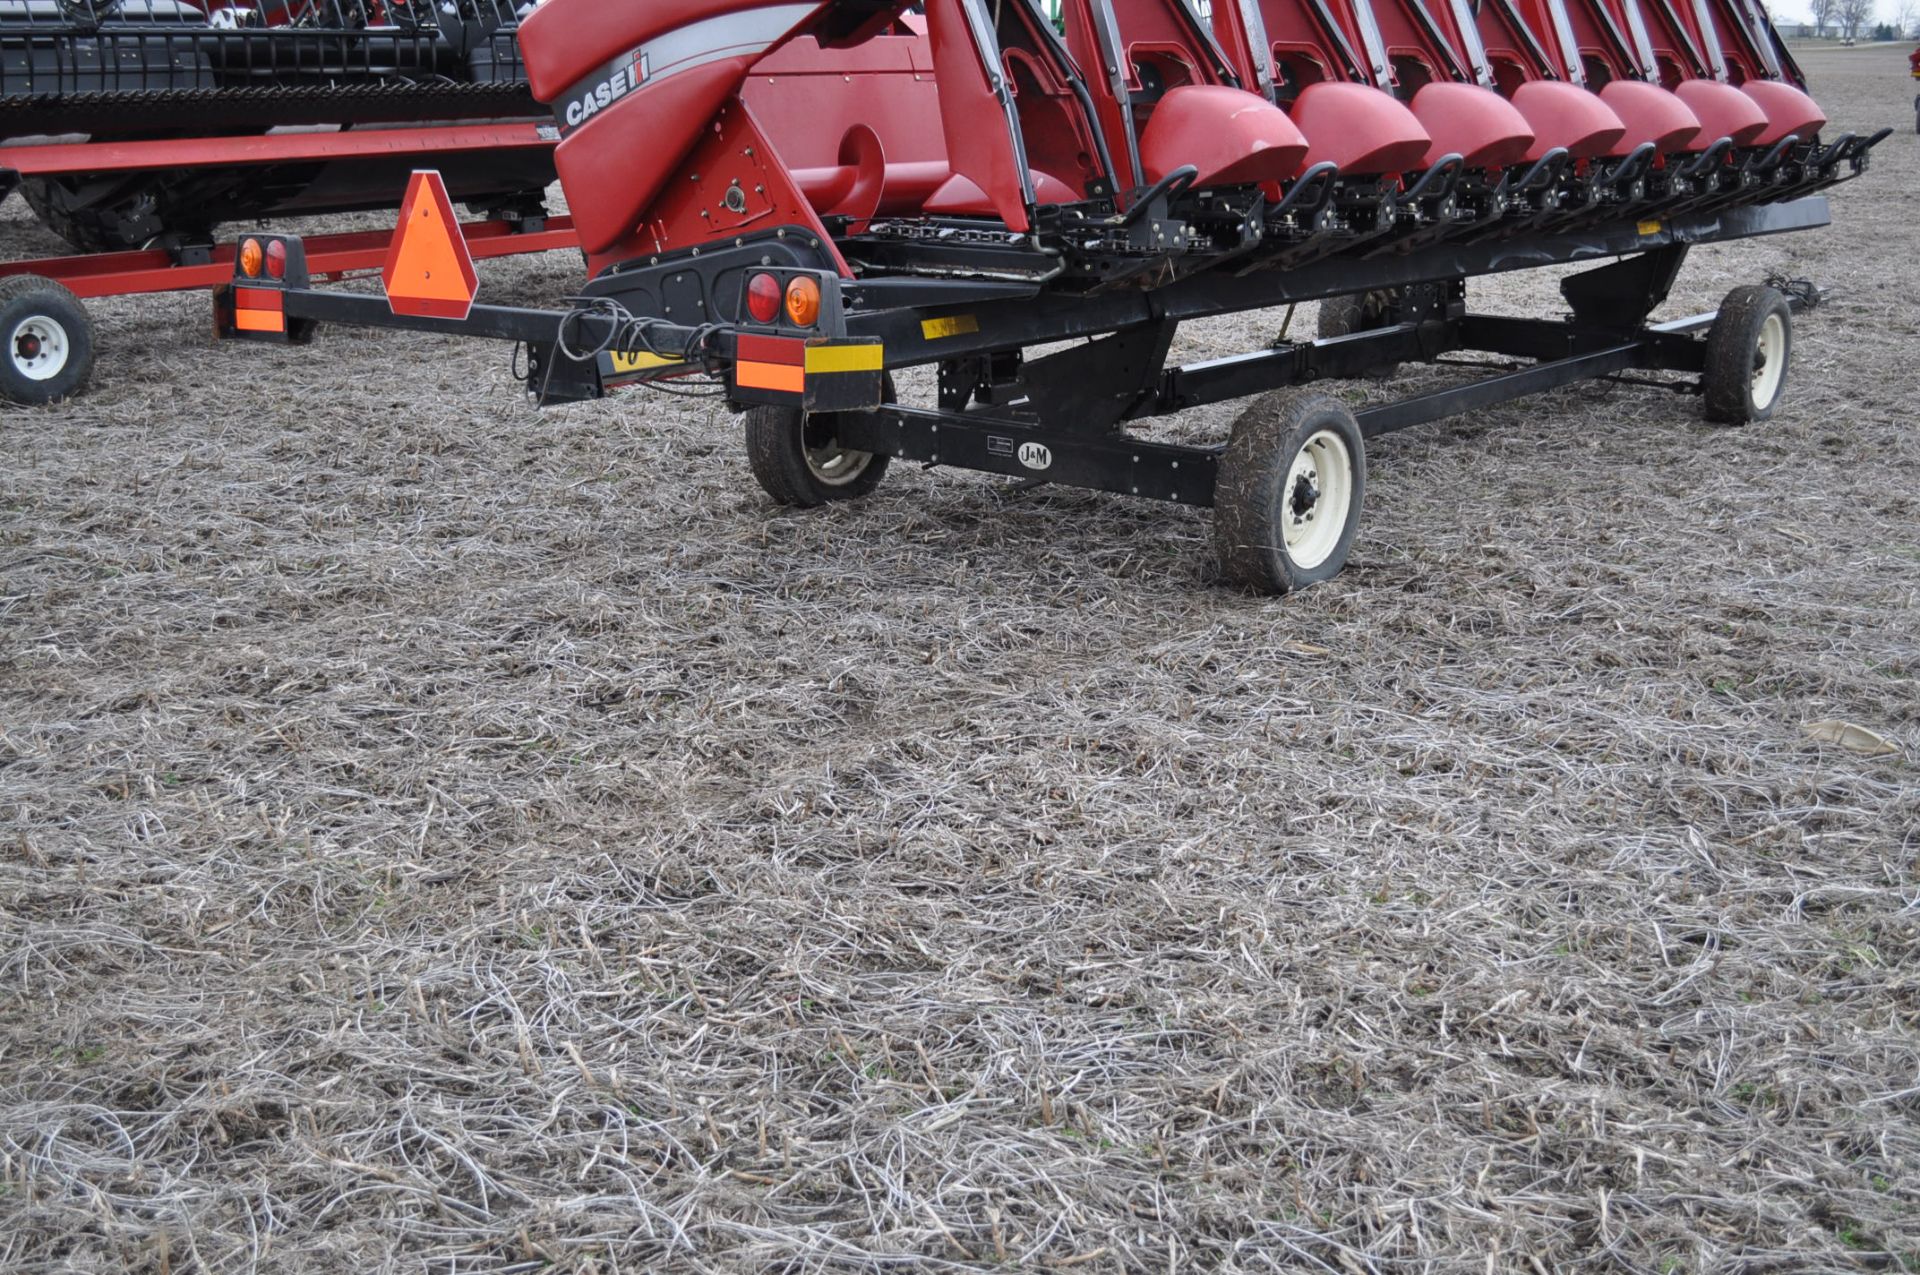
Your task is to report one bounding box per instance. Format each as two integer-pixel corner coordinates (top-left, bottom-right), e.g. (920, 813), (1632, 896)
(219, 196), (1828, 589)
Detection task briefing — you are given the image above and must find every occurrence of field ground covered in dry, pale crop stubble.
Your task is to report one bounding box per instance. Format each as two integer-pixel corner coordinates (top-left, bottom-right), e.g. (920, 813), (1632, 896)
(0, 39), (1920, 1275)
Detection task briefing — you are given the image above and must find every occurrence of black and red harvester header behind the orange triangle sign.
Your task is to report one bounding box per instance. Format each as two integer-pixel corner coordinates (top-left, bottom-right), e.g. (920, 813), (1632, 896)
(0, 0), (553, 252)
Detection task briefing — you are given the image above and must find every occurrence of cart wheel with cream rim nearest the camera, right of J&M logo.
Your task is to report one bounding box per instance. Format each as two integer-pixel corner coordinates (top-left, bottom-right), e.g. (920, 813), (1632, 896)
(1213, 388), (1367, 593)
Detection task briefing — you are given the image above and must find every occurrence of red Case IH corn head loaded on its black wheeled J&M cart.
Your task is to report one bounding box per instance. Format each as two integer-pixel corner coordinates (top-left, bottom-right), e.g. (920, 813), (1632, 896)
(202, 0), (1880, 591)
